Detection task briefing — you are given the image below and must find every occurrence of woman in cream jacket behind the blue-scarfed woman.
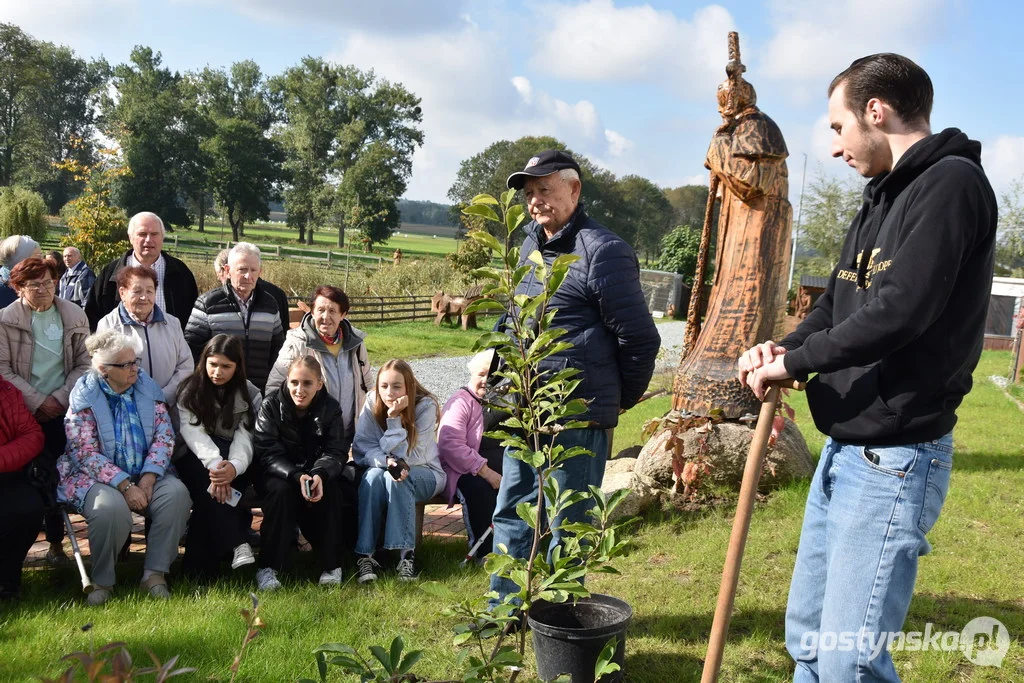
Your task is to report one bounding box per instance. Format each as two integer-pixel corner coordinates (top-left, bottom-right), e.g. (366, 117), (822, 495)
(96, 265), (196, 413)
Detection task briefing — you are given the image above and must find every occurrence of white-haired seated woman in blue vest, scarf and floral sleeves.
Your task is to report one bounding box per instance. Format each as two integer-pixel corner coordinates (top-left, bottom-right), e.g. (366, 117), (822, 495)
(57, 330), (191, 605)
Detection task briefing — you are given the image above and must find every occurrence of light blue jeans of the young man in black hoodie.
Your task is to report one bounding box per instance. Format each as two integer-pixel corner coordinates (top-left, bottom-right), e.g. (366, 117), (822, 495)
(785, 433), (953, 683)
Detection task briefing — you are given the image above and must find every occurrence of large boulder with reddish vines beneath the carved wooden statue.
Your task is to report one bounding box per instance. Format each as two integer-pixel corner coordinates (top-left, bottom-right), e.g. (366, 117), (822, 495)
(679, 420), (814, 490)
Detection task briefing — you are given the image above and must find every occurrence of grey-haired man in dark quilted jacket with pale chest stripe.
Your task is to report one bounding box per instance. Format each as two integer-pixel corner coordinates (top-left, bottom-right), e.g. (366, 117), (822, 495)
(185, 242), (285, 391)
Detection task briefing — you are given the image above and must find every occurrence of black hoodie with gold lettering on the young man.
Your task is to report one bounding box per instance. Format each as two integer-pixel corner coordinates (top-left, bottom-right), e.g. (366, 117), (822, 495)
(781, 128), (996, 445)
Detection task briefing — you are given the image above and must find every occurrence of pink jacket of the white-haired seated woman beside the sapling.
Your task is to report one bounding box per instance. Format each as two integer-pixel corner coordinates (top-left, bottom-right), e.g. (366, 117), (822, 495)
(437, 387), (487, 507)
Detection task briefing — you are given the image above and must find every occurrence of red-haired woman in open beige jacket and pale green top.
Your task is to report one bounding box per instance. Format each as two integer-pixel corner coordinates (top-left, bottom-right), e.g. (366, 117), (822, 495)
(0, 257), (89, 564)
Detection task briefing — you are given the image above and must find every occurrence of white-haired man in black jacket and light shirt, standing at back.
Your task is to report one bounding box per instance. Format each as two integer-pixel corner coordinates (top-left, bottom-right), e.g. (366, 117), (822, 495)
(85, 211), (199, 332)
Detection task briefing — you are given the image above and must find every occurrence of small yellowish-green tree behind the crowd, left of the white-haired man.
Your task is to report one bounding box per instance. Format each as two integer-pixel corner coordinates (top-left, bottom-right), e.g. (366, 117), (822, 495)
(60, 143), (131, 265)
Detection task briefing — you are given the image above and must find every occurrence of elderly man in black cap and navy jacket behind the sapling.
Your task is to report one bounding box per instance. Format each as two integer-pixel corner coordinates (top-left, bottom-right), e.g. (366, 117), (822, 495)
(490, 150), (662, 596)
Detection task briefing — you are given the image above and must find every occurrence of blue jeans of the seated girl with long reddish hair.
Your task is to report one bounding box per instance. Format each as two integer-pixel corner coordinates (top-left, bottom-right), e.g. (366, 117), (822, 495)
(355, 465), (437, 555)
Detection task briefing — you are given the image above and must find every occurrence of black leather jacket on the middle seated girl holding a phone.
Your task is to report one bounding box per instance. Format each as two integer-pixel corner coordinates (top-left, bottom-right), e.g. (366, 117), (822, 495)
(253, 387), (351, 482)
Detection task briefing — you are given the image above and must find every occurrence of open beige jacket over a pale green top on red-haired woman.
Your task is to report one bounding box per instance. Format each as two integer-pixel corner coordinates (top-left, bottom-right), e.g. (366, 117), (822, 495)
(0, 297), (89, 413)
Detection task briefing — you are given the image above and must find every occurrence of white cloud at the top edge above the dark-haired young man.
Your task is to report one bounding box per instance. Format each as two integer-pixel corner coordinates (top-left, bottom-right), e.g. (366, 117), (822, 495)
(758, 0), (946, 84)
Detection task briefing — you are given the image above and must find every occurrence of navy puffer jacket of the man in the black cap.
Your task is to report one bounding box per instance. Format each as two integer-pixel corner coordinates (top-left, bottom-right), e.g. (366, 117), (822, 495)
(516, 207), (662, 429)
